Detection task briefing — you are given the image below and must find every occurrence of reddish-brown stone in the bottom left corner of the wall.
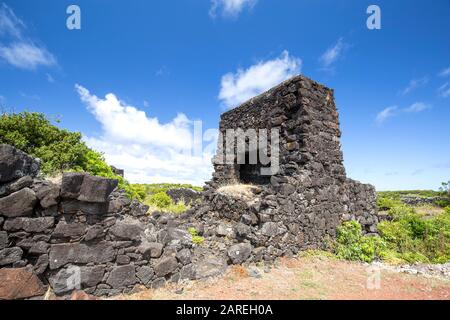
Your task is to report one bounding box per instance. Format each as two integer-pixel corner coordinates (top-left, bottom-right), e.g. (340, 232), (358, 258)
(0, 268), (46, 300)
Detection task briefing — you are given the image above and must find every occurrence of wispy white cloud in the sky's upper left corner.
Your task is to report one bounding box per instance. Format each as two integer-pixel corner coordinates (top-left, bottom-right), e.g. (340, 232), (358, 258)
(0, 4), (56, 70)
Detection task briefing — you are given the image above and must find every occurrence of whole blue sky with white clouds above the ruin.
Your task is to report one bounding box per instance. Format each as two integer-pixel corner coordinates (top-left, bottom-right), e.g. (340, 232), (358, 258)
(0, 0), (450, 190)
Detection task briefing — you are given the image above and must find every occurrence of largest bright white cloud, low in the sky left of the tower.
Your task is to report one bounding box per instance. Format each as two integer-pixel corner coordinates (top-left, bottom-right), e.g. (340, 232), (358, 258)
(76, 85), (216, 185)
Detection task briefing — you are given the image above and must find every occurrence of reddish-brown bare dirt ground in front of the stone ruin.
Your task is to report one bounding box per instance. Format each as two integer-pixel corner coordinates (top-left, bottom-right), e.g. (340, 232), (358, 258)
(116, 257), (450, 300)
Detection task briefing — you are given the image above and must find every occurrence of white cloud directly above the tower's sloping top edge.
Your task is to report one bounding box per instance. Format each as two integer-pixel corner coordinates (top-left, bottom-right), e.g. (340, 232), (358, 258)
(219, 51), (302, 108)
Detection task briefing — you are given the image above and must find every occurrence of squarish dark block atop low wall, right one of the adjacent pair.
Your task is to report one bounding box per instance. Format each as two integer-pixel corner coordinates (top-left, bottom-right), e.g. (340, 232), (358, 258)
(78, 175), (118, 203)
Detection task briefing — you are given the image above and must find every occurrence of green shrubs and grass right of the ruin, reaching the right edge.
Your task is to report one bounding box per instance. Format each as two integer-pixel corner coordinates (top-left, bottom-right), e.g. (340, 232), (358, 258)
(333, 205), (450, 263)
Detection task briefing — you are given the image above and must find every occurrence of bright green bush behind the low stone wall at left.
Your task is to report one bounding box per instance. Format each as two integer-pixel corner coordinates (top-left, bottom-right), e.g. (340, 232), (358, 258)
(0, 111), (143, 200)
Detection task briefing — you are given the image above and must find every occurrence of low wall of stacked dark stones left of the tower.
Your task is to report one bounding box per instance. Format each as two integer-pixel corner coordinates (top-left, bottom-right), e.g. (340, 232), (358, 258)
(0, 145), (204, 299)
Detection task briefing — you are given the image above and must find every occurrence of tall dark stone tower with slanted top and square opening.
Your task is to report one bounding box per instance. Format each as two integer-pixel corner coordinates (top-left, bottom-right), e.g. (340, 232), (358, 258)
(197, 76), (378, 261)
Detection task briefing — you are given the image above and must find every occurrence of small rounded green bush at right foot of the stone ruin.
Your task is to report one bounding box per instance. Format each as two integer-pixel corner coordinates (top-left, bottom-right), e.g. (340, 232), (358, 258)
(335, 221), (385, 262)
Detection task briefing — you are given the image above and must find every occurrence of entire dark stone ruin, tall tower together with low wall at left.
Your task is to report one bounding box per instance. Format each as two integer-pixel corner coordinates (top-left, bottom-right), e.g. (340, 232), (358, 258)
(0, 76), (378, 300)
